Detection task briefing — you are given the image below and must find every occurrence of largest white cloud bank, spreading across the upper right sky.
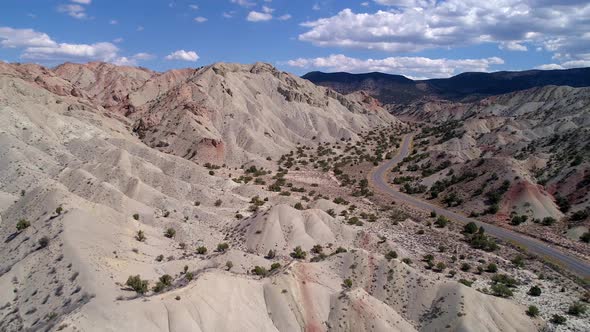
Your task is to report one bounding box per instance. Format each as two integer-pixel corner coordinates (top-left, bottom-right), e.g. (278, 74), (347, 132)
(299, 0), (590, 60)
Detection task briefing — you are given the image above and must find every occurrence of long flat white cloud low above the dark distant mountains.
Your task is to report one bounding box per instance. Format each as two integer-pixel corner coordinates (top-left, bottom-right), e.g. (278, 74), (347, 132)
(285, 54), (504, 78)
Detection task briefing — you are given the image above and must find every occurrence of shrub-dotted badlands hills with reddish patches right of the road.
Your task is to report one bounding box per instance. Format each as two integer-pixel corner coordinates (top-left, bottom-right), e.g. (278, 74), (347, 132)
(391, 86), (590, 252)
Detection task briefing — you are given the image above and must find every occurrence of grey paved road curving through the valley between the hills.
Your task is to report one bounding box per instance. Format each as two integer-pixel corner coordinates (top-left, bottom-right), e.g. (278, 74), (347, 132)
(371, 134), (590, 279)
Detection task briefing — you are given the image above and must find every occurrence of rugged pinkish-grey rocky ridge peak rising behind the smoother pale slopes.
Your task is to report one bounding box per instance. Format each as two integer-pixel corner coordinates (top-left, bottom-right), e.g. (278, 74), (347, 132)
(55, 63), (397, 165)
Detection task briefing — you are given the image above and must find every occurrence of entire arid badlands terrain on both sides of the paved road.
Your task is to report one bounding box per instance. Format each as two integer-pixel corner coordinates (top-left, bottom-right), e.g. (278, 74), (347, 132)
(0, 62), (590, 332)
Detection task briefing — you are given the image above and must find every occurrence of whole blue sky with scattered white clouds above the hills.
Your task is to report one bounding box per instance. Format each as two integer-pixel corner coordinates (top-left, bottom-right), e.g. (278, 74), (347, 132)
(0, 0), (590, 78)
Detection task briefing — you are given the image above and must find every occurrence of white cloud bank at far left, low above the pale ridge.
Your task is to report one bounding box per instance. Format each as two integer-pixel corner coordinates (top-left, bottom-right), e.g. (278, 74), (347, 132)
(0, 27), (153, 63)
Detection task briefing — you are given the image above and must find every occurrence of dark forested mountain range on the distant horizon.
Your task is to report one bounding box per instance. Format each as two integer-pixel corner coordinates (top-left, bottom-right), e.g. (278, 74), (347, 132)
(303, 67), (590, 104)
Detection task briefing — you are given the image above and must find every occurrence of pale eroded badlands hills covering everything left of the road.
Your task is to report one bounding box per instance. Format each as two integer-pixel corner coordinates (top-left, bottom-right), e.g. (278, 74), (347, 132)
(0, 63), (574, 331)
